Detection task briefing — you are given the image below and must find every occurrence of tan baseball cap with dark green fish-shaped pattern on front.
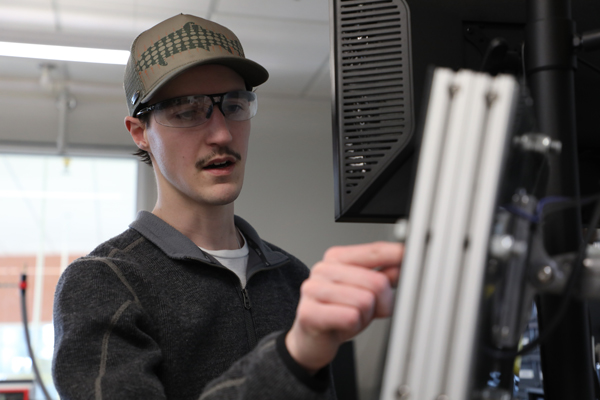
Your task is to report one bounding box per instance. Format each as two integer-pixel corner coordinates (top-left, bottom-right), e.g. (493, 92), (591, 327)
(123, 14), (269, 116)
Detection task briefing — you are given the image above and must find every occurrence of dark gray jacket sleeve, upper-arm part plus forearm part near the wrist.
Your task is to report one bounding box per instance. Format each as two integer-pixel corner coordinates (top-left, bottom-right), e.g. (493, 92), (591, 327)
(52, 259), (334, 400)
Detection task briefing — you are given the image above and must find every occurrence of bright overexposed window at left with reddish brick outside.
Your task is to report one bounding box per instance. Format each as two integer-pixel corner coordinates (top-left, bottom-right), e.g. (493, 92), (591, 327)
(0, 154), (138, 398)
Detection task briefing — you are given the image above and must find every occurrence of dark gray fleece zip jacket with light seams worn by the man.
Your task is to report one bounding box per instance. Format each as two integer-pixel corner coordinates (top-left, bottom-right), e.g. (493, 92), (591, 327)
(52, 212), (334, 400)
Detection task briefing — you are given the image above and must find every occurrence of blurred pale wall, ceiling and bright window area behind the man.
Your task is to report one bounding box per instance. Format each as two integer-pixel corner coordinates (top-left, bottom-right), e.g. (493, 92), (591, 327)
(0, 0), (391, 400)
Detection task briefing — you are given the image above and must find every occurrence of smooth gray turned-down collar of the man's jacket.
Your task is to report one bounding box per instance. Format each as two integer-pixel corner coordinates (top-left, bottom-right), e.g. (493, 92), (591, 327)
(129, 211), (289, 269)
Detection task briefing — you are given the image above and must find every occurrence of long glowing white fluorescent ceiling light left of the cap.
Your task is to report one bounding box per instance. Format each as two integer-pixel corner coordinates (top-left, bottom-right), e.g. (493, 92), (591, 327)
(0, 42), (129, 65)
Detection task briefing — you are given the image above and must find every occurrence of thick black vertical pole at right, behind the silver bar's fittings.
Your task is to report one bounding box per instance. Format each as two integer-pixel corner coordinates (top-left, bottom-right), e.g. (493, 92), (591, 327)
(525, 0), (594, 400)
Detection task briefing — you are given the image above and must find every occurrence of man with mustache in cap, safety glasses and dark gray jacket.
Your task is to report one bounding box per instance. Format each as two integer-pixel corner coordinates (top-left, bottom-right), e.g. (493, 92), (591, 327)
(53, 15), (402, 399)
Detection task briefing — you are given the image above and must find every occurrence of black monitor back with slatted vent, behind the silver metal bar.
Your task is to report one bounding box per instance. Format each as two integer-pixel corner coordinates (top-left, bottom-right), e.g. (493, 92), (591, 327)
(330, 0), (600, 222)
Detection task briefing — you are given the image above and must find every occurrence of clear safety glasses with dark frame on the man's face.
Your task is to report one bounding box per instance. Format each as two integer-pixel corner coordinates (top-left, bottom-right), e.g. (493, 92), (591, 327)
(136, 90), (258, 128)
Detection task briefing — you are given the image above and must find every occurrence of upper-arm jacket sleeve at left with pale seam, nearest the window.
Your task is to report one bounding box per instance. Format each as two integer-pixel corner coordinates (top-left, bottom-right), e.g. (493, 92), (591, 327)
(52, 259), (166, 400)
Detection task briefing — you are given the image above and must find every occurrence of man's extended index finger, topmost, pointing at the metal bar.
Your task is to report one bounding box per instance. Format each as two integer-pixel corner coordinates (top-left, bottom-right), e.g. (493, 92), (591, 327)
(323, 242), (404, 269)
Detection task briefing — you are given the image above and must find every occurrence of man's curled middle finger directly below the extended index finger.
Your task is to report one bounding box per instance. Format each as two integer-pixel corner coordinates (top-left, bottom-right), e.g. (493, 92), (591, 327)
(305, 263), (397, 318)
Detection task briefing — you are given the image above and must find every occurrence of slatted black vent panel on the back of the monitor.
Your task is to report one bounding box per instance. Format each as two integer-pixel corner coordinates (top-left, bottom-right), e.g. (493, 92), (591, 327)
(333, 0), (413, 204)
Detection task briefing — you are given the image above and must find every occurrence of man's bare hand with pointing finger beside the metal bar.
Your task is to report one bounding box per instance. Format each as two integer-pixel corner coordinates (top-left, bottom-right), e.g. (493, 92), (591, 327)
(285, 242), (404, 373)
